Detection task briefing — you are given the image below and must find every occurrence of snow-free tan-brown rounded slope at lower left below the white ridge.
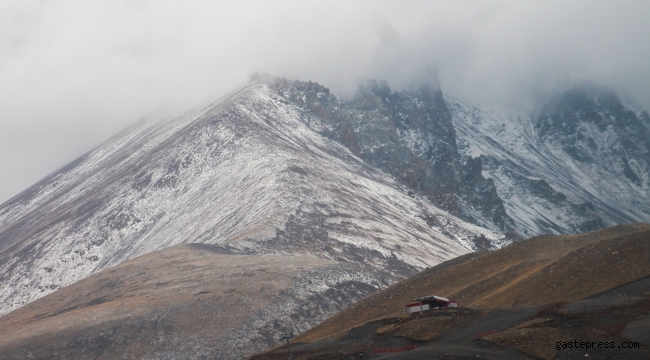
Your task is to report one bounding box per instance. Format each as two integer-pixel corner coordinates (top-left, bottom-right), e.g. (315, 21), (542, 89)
(0, 245), (335, 359)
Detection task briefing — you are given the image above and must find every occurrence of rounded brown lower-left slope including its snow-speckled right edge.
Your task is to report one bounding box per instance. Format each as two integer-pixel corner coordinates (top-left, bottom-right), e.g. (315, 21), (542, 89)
(0, 244), (384, 359)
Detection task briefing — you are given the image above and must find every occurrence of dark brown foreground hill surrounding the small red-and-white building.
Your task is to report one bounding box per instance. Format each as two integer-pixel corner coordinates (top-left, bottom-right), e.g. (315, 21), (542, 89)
(251, 224), (650, 360)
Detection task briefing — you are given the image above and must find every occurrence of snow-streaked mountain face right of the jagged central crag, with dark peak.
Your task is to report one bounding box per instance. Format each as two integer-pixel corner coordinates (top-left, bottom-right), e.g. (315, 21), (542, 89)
(448, 86), (650, 237)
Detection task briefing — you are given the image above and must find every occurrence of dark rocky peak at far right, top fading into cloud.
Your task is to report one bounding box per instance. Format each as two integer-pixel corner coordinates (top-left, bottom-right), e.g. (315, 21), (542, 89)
(535, 87), (650, 198)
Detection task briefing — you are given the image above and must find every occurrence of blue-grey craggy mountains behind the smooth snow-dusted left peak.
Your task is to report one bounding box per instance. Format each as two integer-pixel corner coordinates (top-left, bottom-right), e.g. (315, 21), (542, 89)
(264, 79), (650, 239)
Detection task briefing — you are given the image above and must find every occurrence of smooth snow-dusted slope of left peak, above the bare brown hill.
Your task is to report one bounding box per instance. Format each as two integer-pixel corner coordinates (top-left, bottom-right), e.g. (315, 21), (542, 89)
(0, 82), (504, 314)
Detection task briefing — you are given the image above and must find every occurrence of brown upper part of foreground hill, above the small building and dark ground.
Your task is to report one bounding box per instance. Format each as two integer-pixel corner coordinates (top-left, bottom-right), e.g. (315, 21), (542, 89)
(295, 224), (650, 342)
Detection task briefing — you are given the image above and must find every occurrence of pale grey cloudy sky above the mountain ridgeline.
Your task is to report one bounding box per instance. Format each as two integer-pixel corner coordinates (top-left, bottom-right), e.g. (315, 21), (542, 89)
(0, 0), (650, 202)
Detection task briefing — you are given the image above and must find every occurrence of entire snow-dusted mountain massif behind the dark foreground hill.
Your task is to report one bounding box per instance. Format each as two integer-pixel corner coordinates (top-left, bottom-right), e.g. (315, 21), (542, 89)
(0, 75), (650, 358)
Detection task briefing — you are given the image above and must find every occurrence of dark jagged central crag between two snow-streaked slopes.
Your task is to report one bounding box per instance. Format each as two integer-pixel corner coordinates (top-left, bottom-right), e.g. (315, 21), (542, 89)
(271, 79), (516, 237)
